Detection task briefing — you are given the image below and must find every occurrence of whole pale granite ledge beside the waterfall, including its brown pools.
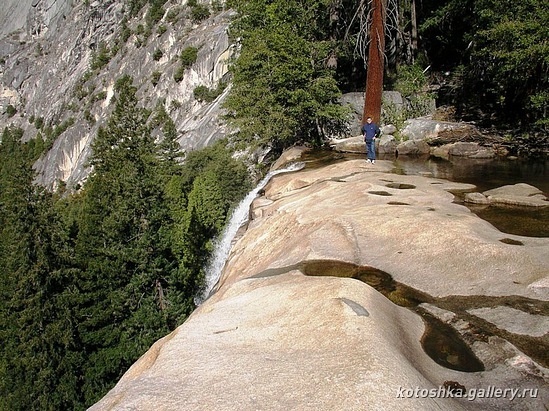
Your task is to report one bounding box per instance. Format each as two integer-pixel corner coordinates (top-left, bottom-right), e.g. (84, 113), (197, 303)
(91, 160), (549, 411)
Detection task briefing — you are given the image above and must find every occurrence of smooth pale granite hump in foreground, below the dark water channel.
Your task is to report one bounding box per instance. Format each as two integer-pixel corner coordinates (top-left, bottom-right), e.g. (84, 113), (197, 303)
(91, 272), (465, 411)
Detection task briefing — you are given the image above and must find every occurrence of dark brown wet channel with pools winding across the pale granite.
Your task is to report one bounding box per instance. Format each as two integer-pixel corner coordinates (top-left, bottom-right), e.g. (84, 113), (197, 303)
(251, 260), (549, 372)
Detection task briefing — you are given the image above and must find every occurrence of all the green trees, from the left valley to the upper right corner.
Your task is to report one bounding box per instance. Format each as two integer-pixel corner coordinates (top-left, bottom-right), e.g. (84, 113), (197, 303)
(0, 0), (549, 411)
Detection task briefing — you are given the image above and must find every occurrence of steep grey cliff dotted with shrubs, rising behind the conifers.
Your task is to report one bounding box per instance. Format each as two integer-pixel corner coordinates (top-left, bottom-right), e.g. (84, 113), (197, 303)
(0, 0), (233, 187)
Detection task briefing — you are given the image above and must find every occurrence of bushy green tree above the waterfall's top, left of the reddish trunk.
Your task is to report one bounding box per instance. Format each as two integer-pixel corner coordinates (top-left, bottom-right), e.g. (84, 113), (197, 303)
(226, 0), (348, 151)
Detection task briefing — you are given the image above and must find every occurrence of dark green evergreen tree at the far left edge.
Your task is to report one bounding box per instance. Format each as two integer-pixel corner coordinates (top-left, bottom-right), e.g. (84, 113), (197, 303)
(0, 130), (82, 410)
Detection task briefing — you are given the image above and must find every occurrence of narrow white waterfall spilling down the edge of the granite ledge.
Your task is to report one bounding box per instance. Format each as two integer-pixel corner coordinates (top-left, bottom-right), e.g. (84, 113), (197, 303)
(195, 163), (305, 305)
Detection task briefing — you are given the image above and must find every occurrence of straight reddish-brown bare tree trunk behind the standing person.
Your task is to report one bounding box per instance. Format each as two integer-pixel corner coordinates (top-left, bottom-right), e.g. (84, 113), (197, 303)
(362, 0), (387, 124)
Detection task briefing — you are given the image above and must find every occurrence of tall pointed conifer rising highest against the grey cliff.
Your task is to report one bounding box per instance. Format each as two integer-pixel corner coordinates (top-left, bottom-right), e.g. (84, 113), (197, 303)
(71, 76), (184, 403)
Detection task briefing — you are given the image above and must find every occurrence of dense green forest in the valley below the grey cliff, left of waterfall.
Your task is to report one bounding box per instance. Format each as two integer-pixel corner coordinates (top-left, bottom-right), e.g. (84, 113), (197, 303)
(0, 76), (250, 410)
